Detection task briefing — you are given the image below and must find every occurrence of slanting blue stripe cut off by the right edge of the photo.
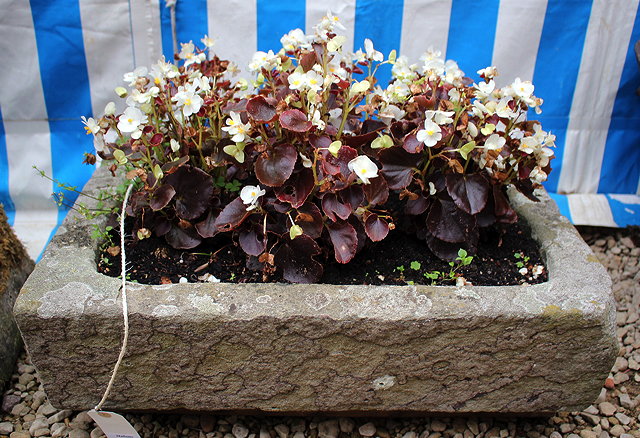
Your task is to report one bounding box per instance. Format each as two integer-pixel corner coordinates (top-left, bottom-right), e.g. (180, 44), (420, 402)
(598, 6), (640, 194)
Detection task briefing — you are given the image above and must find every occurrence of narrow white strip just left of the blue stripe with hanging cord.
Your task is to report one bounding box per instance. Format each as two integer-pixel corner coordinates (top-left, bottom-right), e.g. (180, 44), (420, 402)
(129, 0), (164, 67)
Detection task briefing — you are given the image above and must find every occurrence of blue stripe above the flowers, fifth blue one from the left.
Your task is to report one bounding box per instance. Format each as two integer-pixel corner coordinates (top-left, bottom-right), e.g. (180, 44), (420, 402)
(446, 0), (500, 77)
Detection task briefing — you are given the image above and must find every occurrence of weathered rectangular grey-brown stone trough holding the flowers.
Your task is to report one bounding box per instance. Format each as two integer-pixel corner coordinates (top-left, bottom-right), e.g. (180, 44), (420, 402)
(15, 165), (617, 414)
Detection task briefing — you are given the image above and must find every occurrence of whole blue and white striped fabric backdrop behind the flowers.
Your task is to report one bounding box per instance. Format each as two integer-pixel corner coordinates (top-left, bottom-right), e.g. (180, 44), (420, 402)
(0, 0), (640, 257)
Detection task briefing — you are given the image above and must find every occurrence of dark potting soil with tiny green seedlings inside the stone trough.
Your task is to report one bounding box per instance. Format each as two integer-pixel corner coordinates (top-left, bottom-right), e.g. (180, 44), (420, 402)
(97, 217), (548, 286)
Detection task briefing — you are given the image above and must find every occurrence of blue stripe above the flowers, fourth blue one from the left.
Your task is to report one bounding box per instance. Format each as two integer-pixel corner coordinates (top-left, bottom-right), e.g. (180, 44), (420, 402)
(353, 0), (404, 88)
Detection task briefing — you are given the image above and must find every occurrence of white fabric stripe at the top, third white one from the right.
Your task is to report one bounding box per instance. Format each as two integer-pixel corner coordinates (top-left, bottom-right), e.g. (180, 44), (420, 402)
(400, 0), (452, 63)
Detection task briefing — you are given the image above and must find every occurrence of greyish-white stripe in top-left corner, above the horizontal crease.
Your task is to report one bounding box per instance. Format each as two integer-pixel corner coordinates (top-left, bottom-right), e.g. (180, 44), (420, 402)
(0, 0), (47, 121)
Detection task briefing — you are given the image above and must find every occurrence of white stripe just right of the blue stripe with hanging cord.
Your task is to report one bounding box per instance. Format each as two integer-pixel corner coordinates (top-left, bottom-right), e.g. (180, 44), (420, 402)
(207, 0), (258, 79)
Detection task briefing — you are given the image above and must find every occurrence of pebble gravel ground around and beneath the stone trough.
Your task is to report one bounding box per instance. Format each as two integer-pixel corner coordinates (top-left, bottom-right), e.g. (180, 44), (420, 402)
(0, 228), (640, 438)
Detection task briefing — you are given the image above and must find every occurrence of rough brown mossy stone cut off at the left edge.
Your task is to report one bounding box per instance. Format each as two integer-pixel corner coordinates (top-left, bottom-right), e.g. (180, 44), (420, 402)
(0, 204), (33, 390)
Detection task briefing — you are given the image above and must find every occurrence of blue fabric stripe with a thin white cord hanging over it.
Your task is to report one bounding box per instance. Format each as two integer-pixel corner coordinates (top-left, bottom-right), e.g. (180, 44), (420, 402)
(160, 0), (209, 62)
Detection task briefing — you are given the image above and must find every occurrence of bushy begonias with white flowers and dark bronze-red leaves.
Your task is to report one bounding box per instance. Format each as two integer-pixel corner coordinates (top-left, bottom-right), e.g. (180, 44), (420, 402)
(83, 13), (554, 282)
